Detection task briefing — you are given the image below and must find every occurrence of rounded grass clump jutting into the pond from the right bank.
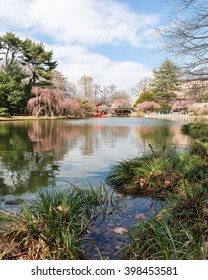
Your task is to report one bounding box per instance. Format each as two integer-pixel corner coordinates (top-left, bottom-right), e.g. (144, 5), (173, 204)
(106, 152), (182, 197)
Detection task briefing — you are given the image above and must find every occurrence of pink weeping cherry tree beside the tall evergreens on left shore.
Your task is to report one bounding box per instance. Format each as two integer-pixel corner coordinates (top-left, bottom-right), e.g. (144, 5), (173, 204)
(27, 87), (83, 117)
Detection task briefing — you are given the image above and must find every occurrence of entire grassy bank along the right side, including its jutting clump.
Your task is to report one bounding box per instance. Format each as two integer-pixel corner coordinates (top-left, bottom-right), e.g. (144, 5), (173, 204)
(107, 123), (208, 260)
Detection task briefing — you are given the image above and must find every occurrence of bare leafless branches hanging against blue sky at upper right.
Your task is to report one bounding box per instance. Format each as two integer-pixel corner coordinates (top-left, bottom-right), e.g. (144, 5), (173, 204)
(161, 0), (208, 80)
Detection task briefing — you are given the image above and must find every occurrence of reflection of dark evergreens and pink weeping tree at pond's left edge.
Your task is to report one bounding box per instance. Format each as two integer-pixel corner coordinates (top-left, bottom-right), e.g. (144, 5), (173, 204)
(0, 121), (78, 195)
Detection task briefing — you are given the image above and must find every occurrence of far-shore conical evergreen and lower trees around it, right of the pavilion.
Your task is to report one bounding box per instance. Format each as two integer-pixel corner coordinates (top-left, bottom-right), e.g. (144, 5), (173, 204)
(133, 59), (208, 110)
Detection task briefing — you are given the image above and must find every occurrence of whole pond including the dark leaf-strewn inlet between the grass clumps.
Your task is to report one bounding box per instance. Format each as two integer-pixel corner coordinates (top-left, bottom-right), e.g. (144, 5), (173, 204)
(0, 117), (189, 259)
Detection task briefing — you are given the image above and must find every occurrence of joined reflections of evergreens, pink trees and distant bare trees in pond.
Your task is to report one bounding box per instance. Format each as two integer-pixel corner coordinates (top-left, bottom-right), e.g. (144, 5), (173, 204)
(0, 120), (130, 195)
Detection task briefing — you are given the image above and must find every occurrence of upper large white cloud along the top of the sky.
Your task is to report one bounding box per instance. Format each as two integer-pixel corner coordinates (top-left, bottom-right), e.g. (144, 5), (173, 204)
(0, 0), (158, 46)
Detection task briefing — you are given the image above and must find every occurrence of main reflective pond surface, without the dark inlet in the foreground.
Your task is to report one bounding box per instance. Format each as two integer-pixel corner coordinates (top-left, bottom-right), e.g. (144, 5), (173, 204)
(0, 118), (188, 196)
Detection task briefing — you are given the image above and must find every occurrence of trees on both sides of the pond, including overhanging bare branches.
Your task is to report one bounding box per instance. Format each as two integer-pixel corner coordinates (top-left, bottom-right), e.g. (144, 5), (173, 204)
(0, 0), (208, 116)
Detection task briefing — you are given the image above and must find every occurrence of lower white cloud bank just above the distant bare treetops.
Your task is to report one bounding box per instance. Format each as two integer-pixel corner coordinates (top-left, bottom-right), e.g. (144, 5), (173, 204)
(49, 46), (152, 92)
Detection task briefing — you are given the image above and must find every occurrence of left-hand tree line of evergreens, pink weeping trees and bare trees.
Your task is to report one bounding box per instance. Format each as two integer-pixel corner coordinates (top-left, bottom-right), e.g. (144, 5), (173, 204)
(0, 32), (129, 117)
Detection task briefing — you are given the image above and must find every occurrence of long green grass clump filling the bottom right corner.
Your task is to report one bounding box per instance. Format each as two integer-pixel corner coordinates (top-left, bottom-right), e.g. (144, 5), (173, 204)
(123, 185), (208, 260)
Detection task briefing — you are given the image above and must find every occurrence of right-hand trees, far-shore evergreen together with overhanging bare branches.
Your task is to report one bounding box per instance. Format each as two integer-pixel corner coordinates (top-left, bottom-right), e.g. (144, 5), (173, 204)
(134, 0), (208, 112)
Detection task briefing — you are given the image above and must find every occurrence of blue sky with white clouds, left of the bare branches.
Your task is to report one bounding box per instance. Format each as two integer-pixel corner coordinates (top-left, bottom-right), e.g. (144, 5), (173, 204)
(0, 0), (169, 93)
